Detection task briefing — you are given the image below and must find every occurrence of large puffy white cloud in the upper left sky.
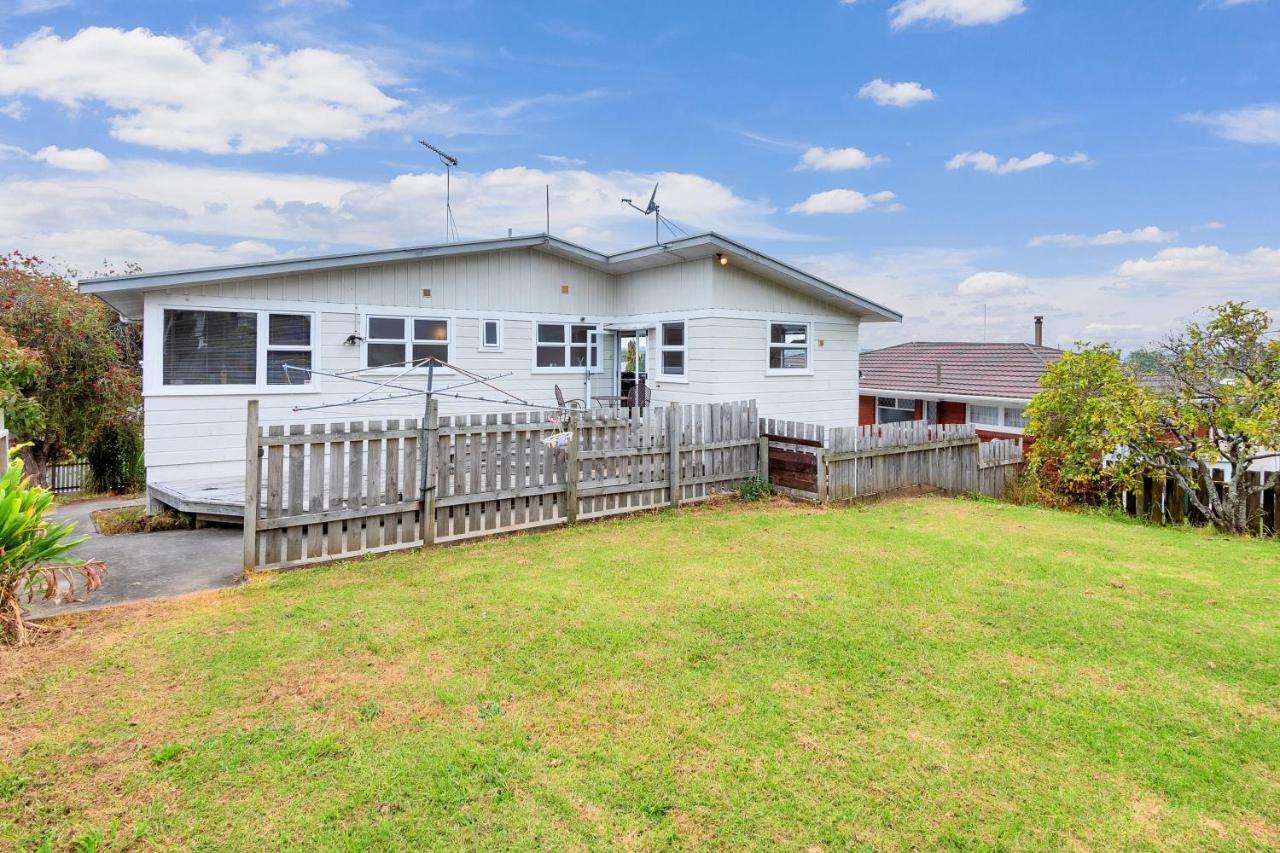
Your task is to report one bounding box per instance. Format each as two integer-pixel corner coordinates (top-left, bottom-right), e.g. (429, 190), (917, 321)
(0, 27), (404, 154)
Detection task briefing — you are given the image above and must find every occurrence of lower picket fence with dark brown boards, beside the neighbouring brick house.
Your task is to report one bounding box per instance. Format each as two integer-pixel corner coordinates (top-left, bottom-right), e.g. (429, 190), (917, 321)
(760, 420), (1023, 502)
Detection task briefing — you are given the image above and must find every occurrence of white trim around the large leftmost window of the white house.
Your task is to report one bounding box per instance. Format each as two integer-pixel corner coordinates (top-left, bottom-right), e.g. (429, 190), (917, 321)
(142, 302), (324, 397)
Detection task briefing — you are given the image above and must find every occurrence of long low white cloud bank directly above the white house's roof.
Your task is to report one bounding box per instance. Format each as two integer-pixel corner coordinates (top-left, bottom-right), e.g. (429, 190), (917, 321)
(0, 160), (796, 269)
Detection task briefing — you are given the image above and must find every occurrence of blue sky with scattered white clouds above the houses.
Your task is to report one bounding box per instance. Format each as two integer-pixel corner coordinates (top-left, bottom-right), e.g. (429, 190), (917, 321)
(0, 0), (1280, 347)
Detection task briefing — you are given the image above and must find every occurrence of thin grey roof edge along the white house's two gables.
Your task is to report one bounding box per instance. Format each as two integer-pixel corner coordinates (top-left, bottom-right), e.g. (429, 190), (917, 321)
(81, 232), (902, 323)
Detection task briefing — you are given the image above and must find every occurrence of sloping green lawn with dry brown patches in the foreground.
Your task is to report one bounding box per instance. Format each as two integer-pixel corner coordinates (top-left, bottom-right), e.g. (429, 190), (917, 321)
(0, 498), (1280, 849)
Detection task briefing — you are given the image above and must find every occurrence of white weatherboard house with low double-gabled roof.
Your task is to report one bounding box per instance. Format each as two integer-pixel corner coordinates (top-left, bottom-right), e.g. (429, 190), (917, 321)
(81, 234), (901, 502)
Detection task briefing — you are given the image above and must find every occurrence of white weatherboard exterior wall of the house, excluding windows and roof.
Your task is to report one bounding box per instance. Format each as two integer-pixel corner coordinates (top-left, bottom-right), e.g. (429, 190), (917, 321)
(143, 251), (858, 482)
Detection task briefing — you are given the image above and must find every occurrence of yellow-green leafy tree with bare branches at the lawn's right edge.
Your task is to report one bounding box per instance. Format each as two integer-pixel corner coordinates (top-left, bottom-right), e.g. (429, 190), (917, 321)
(1027, 302), (1280, 533)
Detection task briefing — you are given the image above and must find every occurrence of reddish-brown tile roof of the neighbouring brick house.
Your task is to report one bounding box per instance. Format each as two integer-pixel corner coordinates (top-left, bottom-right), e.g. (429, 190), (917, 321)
(860, 342), (1062, 400)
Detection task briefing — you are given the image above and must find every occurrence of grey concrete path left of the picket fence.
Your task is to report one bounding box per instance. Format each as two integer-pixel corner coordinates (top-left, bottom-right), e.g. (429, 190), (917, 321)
(24, 498), (243, 619)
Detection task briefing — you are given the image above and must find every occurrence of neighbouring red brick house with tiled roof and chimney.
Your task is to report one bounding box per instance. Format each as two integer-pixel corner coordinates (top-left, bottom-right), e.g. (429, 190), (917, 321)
(858, 316), (1062, 441)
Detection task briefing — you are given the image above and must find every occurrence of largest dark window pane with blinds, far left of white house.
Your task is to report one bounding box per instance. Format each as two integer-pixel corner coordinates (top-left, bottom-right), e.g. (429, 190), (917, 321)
(163, 310), (257, 386)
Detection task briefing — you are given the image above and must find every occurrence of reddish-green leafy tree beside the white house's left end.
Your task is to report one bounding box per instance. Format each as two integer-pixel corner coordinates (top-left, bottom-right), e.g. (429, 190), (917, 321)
(0, 252), (140, 483)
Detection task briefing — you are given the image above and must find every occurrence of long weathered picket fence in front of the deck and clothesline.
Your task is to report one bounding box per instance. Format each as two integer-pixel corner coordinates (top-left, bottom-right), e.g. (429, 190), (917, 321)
(244, 401), (759, 569)
